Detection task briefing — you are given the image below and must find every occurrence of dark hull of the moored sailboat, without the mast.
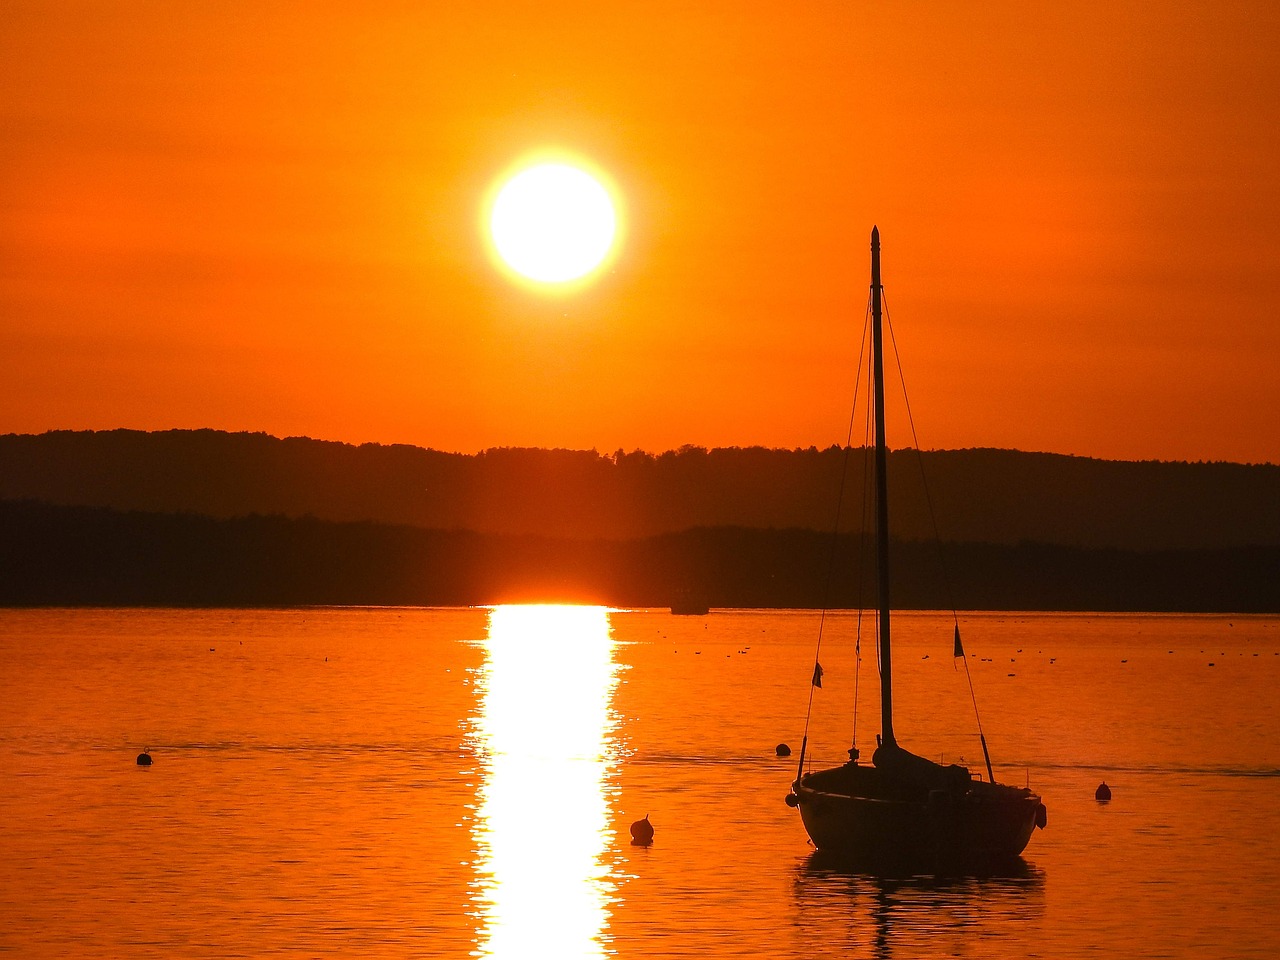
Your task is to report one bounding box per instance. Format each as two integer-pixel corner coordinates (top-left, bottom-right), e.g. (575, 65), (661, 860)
(792, 764), (1046, 868)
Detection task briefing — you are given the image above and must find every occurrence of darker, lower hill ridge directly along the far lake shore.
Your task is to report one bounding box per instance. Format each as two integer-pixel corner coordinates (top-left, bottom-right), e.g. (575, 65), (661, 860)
(0, 500), (1280, 613)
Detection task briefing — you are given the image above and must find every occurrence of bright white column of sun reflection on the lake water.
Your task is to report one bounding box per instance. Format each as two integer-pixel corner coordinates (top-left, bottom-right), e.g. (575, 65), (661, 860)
(472, 605), (618, 960)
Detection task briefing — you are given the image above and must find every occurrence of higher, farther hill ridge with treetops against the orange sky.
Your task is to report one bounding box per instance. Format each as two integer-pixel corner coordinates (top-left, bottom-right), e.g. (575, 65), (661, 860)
(0, 430), (1280, 550)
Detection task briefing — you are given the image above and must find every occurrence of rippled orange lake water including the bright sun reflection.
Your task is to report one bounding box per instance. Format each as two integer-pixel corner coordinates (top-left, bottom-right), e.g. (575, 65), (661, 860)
(0, 607), (1280, 959)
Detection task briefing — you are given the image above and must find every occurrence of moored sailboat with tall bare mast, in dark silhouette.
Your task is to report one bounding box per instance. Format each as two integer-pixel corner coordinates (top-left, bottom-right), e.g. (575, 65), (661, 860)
(786, 228), (1047, 868)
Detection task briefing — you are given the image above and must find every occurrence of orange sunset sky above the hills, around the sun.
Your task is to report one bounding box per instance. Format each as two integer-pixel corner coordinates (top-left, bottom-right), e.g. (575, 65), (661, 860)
(0, 0), (1280, 462)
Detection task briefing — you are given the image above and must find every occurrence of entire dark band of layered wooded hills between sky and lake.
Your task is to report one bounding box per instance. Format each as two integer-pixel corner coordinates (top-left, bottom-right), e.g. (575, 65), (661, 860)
(0, 430), (1280, 612)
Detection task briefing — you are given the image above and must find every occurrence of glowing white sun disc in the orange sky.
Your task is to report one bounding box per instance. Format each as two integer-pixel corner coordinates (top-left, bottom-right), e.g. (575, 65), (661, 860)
(489, 163), (617, 283)
